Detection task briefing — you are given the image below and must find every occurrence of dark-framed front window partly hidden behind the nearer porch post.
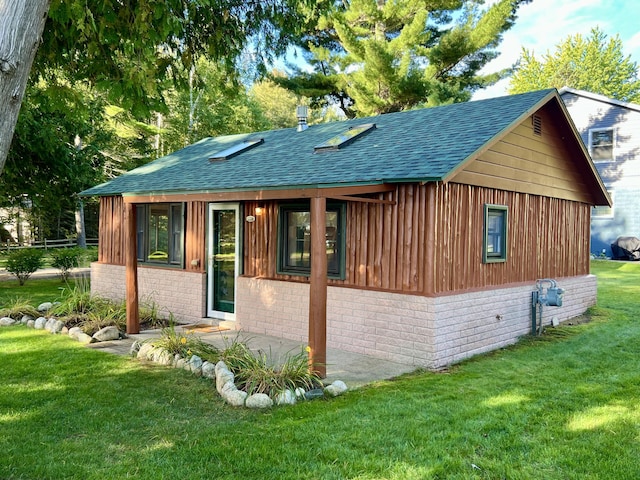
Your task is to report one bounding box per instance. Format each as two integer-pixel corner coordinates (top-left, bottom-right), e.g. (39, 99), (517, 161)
(278, 203), (345, 278)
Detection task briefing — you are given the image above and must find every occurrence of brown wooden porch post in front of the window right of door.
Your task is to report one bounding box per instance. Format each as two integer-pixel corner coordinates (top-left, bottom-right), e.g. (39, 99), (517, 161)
(309, 197), (327, 378)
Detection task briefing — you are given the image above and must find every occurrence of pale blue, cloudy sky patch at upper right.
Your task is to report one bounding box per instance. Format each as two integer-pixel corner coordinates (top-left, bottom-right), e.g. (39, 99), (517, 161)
(473, 0), (640, 99)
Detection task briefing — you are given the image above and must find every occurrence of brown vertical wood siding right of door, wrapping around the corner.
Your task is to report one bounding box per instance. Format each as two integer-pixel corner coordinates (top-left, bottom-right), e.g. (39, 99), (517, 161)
(244, 183), (590, 295)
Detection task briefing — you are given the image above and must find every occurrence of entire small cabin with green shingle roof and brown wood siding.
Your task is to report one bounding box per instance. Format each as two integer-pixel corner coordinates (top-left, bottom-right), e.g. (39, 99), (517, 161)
(83, 89), (610, 369)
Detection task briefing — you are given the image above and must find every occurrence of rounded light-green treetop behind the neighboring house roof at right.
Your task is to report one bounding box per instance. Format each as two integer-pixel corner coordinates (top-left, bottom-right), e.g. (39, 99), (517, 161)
(509, 28), (640, 102)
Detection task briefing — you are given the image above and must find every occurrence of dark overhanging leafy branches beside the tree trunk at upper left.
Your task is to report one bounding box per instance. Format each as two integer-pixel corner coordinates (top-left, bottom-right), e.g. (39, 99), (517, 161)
(35, 0), (320, 116)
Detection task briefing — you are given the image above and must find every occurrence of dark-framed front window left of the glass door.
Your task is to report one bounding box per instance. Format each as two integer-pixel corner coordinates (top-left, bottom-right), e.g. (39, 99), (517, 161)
(136, 203), (184, 266)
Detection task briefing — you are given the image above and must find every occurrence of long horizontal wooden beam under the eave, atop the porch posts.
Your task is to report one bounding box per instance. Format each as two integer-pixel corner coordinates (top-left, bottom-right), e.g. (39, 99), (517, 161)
(123, 183), (396, 203)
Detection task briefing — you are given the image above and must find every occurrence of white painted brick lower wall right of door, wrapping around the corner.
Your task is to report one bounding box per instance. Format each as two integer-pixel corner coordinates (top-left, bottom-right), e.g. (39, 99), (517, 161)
(237, 275), (597, 369)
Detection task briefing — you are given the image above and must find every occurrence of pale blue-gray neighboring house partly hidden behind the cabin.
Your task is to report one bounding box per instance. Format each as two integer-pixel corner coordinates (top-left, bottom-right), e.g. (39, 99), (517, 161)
(560, 87), (640, 257)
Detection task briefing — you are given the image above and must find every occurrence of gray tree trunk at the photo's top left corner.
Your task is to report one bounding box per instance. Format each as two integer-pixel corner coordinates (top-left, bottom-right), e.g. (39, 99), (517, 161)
(0, 0), (50, 174)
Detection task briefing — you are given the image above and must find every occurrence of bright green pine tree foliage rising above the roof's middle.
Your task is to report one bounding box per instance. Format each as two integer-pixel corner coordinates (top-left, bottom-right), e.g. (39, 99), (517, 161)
(275, 0), (528, 117)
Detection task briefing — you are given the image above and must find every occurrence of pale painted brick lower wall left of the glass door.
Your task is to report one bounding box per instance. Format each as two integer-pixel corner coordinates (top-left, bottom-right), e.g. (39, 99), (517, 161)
(91, 262), (207, 323)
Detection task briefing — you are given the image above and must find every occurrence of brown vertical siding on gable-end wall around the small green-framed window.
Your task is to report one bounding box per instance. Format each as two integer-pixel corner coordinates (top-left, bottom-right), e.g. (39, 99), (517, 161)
(425, 184), (590, 294)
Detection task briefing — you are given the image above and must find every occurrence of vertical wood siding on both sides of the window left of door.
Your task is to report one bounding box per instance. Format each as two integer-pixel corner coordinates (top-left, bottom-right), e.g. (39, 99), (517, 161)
(98, 196), (207, 272)
